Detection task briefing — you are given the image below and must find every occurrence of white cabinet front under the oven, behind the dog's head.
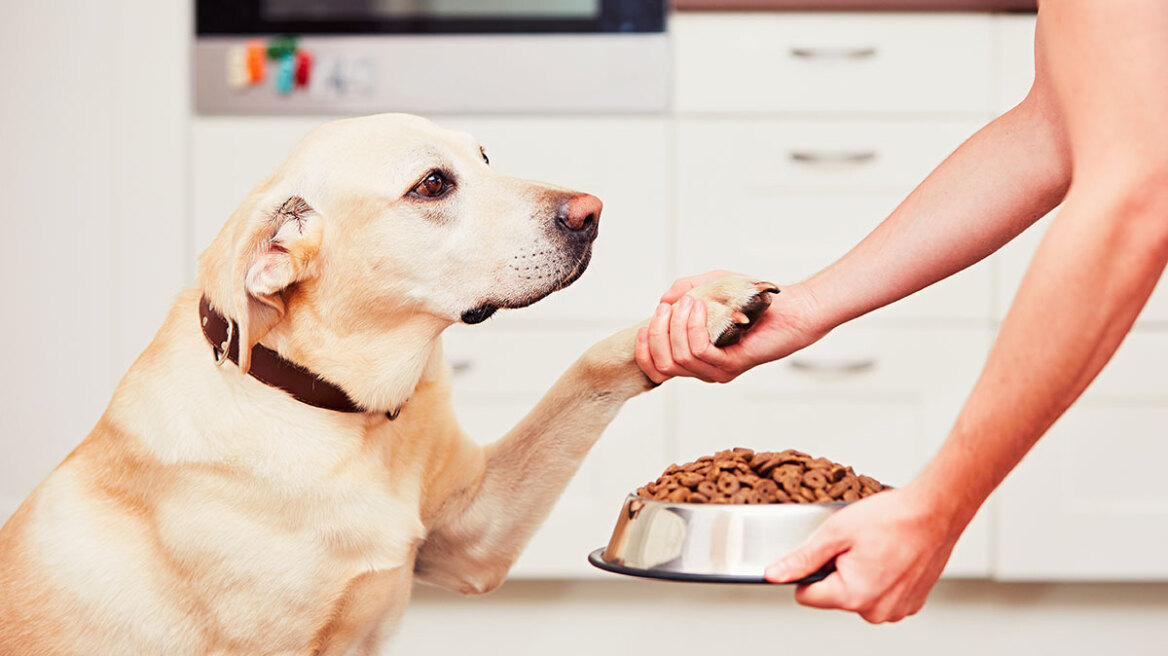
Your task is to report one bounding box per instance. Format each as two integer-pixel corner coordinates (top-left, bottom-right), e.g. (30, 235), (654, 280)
(193, 117), (669, 329)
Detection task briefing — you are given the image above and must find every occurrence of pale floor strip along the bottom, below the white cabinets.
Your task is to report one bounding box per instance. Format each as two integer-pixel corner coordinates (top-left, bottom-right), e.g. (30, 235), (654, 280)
(384, 580), (1168, 656)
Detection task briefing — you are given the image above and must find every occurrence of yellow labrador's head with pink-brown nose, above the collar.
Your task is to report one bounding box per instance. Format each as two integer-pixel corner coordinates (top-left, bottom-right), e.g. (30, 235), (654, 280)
(200, 114), (602, 380)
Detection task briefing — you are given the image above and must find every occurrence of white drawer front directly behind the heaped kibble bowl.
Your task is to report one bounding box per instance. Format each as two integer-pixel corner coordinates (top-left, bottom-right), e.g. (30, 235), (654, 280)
(670, 320), (990, 577)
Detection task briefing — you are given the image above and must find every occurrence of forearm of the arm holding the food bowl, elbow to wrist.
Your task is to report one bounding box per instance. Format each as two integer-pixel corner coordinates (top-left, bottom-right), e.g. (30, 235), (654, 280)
(913, 180), (1168, 530)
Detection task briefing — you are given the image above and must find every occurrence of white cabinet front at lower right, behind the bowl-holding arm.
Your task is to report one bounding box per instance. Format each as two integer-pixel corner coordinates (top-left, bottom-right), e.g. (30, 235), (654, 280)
(994, 329), (1168, 580)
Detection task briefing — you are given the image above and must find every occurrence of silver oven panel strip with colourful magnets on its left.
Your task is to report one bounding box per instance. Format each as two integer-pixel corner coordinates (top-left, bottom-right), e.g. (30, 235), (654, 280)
(194, 33), (672, 114)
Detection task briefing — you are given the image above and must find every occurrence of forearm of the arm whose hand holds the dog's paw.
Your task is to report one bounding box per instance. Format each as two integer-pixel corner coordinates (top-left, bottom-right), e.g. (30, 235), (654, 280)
(804, 99), (1070, 330)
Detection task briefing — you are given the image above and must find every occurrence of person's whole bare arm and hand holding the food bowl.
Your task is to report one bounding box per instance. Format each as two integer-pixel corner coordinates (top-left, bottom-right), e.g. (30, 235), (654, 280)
(767, 0), (1168, 622)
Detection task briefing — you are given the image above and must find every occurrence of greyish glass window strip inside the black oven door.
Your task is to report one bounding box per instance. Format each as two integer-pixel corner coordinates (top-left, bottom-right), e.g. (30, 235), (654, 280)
(262, 0), (600, 21)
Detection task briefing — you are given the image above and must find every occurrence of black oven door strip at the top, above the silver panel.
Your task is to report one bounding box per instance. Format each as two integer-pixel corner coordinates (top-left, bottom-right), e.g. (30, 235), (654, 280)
(195, 0), (666, 36)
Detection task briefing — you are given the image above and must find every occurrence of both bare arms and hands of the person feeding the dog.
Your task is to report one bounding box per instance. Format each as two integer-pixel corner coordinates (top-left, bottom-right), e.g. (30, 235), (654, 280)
(637, 0), (1168, 622)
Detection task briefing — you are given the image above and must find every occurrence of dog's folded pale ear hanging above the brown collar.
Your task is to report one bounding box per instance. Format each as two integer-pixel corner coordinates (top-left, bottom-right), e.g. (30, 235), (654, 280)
(232, 196), (324, 372)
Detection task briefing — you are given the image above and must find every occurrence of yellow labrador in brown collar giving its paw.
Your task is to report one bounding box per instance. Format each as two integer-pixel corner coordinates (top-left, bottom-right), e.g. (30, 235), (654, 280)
(0, 114), (774, 656)
